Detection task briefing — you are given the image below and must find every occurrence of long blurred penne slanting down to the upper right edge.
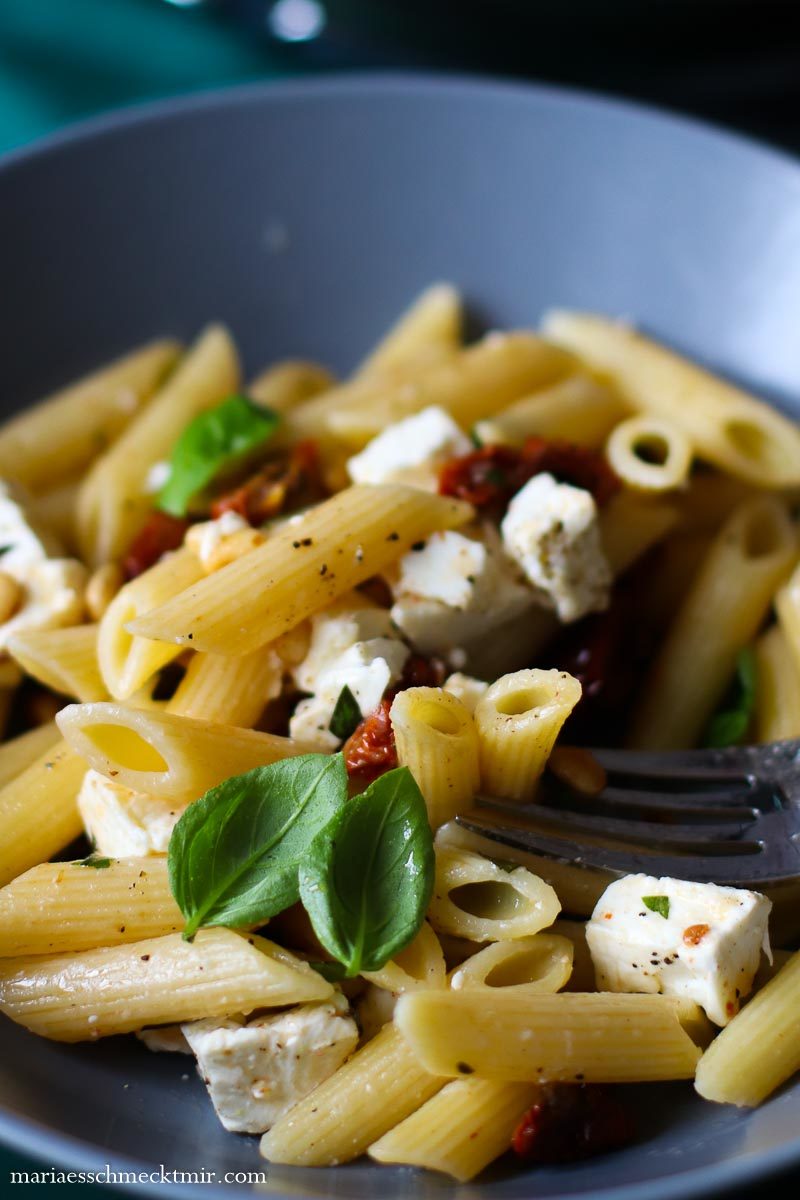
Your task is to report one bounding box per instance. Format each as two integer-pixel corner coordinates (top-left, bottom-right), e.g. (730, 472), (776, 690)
(542, 311), (800, 487)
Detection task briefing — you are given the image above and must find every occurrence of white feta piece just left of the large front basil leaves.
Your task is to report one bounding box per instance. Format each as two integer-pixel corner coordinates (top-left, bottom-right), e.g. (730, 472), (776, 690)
(78, 769), (184, 858)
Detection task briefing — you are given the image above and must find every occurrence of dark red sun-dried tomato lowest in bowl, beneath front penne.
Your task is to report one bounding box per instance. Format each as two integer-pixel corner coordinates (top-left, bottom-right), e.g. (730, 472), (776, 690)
(511, 1084), (634, 1163)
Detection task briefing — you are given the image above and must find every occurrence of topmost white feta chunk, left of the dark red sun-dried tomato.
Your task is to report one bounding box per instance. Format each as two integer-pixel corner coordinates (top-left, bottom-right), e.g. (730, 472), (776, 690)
(347, 406), (473, 488)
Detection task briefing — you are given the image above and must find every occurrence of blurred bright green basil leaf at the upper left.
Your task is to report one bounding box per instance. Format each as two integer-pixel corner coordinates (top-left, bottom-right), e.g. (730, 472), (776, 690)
(157, 396), (281, 517)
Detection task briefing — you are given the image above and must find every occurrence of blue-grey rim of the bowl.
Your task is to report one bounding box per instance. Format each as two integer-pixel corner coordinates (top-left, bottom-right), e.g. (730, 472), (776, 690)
(0, 70), (800, 1200)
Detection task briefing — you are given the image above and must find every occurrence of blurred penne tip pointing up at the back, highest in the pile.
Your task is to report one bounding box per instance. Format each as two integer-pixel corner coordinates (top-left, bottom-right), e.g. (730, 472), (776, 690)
(357, 283), (463, 377)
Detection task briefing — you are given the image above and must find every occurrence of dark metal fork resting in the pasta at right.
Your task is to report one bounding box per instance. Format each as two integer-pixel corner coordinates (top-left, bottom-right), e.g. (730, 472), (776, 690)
(456, 739), (800, 889)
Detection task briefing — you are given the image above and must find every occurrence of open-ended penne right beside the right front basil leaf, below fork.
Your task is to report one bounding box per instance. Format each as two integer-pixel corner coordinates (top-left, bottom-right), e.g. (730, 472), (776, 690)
(428, 844), (561, 942)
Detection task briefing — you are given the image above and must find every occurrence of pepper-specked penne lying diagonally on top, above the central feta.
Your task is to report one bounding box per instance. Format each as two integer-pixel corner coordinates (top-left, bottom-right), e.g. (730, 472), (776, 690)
(128, 484), (473, 654)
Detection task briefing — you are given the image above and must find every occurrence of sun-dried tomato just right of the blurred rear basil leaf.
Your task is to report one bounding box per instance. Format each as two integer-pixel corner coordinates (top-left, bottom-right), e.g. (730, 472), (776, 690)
(211, 442), (327, 526)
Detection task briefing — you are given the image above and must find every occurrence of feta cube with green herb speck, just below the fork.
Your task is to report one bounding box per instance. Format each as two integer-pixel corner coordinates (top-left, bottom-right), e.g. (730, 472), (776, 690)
(587, 875), (772, 1025)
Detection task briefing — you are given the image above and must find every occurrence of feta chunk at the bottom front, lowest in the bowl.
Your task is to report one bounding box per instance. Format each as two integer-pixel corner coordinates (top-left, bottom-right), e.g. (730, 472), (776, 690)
(182, 996), (359, 1133)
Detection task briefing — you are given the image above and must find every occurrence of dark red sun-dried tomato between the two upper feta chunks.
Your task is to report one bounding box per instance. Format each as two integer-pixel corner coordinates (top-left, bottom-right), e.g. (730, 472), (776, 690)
(439, 437), (620, 509)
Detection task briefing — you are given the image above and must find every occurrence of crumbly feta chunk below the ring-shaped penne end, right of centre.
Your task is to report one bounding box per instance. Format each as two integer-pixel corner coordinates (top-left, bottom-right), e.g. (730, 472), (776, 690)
(500, 473), (612, 622)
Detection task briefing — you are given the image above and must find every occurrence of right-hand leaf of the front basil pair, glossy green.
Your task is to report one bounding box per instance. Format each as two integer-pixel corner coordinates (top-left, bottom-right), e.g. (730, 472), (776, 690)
(300, 767), (434, 977)
